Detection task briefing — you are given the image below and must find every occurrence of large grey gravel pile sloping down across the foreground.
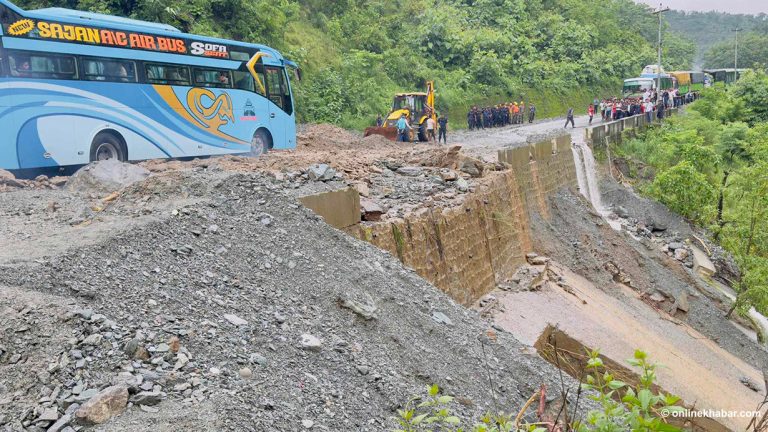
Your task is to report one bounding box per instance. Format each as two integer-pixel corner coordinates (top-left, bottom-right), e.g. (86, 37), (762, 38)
(0, 172), (575, 432)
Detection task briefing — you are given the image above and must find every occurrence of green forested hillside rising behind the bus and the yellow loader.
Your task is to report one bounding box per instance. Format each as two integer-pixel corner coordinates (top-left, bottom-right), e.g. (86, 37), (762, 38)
(13, 0), (695, 128)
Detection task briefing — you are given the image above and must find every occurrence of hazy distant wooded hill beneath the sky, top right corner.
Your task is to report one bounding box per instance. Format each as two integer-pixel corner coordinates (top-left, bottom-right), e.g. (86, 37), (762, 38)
(666, 11), (768, 68)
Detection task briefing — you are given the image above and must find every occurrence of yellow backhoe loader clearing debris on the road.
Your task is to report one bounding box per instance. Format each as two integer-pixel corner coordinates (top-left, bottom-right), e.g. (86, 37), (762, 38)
(365, 81), (437, 141)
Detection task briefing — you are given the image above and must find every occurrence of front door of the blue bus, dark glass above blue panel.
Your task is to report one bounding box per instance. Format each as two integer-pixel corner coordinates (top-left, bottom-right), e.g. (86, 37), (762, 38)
(264, 66), (296, 148)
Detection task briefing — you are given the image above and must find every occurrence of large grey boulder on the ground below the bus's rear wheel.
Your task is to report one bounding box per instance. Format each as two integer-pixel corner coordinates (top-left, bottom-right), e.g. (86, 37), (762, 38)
(67, 159), (149, 193)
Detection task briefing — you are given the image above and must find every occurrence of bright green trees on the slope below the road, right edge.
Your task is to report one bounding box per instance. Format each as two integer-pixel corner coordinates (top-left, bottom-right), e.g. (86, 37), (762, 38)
(613, 71), (768, 314)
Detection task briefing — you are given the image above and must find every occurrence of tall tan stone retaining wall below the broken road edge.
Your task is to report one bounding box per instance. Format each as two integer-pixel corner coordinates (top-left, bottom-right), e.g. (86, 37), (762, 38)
(347, 135), (576, 305)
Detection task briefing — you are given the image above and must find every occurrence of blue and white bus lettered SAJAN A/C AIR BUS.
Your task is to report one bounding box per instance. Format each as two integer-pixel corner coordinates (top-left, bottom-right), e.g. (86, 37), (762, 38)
(0, 0), (299, 170)
